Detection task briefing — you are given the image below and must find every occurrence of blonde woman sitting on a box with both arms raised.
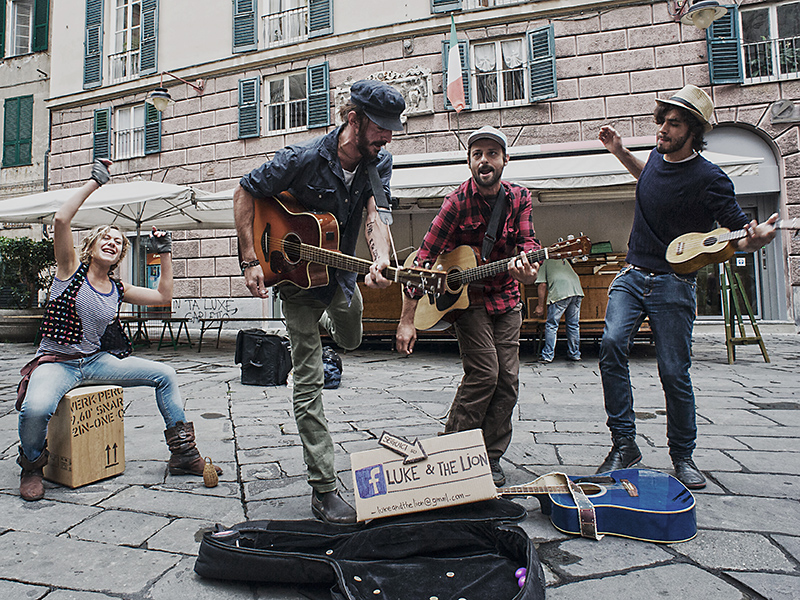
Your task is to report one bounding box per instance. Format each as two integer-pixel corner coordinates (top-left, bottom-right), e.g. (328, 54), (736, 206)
(17, 160), (222, 501)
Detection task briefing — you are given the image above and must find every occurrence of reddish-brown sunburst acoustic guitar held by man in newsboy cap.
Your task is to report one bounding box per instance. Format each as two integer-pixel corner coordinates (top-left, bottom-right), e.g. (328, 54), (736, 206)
(253, 192), (444, 294)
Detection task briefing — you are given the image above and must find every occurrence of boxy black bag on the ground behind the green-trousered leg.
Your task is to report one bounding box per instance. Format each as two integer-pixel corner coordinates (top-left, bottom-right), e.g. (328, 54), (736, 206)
(233, 329), (292, 385)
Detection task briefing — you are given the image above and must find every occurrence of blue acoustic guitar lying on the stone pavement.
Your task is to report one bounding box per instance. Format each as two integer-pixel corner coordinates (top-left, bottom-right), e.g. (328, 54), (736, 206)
(504, 469), (697, 543)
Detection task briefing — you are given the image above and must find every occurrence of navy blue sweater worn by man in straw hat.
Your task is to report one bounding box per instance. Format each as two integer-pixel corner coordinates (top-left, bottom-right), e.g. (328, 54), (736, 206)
(626, 149), (748, 273)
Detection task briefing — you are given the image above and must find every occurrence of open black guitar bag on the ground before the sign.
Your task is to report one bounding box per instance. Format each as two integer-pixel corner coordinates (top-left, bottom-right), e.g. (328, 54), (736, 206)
(194, 499), (545, 600)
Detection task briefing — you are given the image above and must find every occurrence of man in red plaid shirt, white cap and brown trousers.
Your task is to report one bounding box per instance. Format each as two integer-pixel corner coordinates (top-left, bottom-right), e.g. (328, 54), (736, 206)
(396, 127), (539, 487)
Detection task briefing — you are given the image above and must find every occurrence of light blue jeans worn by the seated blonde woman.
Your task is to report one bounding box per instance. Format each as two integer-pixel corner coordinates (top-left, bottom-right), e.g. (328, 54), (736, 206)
(19, 352), (186, 462)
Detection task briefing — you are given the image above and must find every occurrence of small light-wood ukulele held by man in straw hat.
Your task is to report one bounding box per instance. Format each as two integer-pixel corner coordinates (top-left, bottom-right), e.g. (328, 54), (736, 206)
(666, 219), (800, 274)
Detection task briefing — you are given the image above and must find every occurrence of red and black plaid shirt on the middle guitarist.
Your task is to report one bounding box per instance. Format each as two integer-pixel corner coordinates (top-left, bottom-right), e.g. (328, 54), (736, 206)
(406, 178), (541, 315)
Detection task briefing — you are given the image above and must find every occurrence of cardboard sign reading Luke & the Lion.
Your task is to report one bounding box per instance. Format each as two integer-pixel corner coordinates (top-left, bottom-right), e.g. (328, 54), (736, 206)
(350, 429), (497, 521)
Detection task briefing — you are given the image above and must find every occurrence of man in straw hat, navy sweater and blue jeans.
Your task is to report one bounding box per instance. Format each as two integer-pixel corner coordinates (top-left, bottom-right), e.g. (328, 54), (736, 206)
(597, 85), (778, 489)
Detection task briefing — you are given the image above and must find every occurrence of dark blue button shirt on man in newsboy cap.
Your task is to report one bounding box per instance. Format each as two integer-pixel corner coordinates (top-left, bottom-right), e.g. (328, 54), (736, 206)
(239, 127), (392, 304)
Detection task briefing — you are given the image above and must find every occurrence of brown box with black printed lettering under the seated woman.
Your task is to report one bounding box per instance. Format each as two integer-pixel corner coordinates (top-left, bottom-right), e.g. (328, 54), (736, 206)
(44, 385), (125, 488)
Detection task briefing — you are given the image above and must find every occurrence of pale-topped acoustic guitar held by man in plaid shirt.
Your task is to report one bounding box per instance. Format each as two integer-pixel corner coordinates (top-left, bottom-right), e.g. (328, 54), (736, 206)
(405, 236), (592, 330)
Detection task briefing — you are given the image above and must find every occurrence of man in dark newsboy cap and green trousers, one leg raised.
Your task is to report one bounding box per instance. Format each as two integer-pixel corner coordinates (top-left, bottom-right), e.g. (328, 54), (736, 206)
(233, 80), (405, 524)
